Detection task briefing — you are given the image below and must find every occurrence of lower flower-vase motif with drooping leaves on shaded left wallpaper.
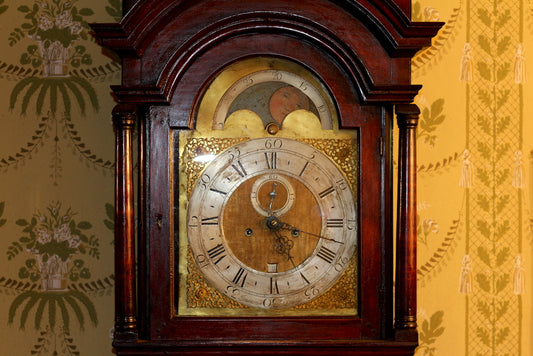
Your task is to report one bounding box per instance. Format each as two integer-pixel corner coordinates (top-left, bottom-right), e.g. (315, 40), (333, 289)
(7, 202), (100, 352)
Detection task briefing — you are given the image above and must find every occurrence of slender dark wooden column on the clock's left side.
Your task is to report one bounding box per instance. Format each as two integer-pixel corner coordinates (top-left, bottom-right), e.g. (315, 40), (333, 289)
(113, 104), (137, 342)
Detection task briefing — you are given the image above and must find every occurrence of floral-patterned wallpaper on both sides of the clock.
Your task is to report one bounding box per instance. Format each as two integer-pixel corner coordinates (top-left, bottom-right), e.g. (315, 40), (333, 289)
(0, 0), (533, 356)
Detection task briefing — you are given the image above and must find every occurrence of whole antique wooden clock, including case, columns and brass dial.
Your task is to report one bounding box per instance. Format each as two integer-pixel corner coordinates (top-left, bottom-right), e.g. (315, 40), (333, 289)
(92, 0), (442, 355)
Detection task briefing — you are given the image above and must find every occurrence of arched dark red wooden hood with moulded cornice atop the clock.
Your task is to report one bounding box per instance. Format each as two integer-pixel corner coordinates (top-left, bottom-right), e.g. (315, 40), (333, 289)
(92, 0), (441, 104)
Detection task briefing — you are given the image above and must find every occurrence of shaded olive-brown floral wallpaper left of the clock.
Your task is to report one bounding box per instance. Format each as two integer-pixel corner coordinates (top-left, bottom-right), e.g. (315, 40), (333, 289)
(0, 0), (121, 355)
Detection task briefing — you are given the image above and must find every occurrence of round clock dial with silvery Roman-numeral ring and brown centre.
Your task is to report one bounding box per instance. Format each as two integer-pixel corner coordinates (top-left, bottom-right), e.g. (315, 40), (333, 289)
(187, 138), (357, 309)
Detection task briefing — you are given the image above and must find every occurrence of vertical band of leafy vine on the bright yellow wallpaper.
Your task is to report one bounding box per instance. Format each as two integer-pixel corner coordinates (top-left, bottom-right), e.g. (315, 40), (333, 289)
(467, 1), (520, 355)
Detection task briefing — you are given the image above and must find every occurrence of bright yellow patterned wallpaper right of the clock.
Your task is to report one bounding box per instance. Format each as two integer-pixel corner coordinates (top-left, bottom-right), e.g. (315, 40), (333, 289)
(412, 0), (533, 356)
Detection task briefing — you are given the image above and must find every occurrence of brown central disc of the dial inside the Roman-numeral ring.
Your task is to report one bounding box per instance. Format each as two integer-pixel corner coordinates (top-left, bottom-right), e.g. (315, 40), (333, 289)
(222, 174), (322, 273)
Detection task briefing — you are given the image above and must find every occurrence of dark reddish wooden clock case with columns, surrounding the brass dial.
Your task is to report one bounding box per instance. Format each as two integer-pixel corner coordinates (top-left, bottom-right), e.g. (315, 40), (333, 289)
(92, 0), (442, 355)
